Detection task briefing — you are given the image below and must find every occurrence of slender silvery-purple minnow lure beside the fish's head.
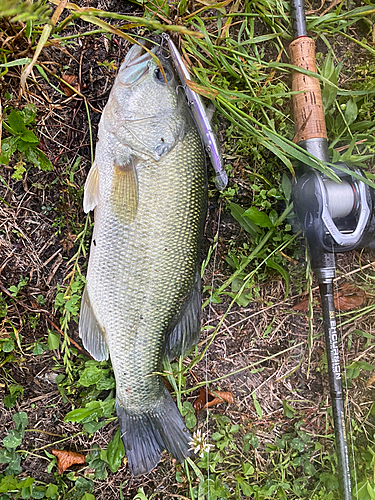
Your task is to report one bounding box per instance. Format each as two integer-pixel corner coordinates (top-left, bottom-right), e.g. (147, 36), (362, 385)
(163, 33), (228, 191)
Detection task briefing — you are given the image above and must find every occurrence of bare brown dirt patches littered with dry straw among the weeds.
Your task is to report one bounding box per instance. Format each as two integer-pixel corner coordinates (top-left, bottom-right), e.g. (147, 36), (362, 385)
(0, 0), (375, 500)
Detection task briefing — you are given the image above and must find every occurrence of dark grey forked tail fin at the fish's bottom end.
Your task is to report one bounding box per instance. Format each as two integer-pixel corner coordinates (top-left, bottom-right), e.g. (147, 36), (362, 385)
(116, 388), (191, 476)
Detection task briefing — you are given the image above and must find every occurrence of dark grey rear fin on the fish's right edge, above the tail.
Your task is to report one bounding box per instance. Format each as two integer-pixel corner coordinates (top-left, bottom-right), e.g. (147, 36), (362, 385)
(164, 271), (201, 359)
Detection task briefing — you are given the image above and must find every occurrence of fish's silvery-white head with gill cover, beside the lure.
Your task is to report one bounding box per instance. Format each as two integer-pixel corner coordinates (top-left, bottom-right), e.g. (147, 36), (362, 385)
(103, 45), (189, 161)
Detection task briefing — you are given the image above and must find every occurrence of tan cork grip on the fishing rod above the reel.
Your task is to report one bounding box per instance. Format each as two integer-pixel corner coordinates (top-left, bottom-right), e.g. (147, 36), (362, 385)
(289, 36), (327, 143)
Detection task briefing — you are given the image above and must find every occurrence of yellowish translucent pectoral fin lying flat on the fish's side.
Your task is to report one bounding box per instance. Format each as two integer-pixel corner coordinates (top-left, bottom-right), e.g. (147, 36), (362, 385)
(111, 157), (138, 224)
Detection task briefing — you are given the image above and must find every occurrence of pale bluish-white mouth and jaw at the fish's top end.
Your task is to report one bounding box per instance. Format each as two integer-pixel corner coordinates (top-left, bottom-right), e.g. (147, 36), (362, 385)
(118, 45), (158, 87)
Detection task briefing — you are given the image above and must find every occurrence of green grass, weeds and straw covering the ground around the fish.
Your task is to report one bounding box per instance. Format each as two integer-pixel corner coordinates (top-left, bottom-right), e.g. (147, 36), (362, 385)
(0, 0), (375, 500)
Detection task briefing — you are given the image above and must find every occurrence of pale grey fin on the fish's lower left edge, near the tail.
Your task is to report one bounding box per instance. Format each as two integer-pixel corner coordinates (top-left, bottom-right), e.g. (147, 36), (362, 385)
(79, 287), (108, 361)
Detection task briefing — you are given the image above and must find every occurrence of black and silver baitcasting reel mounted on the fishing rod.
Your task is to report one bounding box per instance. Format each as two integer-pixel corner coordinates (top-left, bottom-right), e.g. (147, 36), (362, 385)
(293, 163), (375, 253)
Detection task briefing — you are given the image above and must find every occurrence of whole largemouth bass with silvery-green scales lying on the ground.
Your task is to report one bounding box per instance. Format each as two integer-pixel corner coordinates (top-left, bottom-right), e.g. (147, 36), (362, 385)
(79, 45), (206, 475)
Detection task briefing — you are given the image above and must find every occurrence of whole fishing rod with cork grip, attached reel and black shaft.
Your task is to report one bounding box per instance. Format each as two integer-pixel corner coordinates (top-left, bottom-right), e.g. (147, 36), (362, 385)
(289, 0), (375, 500)
